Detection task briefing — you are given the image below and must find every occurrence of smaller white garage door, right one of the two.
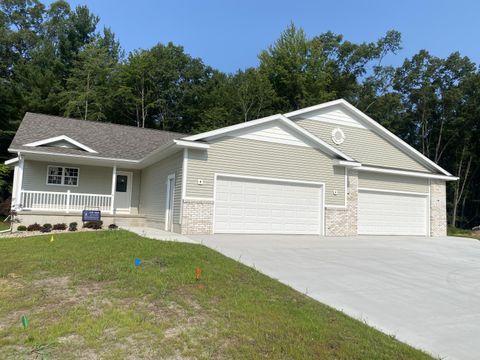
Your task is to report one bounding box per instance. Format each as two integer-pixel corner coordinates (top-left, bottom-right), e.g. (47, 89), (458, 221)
(358, 190), (428, 235)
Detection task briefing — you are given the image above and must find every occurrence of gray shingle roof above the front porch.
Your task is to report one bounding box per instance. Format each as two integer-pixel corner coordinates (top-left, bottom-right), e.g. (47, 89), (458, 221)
(10, 112), (186, 160)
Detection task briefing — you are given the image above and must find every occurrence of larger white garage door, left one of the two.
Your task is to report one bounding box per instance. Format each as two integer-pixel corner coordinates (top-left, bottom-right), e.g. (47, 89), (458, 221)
(214, 177), (323, 234)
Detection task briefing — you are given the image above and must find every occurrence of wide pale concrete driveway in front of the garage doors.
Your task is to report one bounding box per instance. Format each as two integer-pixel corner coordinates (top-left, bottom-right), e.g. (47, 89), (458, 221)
(192, 235), (480, 359)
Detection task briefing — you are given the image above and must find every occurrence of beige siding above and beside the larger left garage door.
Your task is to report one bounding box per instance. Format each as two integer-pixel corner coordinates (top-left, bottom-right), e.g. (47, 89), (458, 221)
(186, 137), (345, 205)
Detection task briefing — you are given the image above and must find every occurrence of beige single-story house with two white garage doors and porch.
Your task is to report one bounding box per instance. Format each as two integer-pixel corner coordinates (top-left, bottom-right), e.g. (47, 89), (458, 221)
(6, 100), (457, 236)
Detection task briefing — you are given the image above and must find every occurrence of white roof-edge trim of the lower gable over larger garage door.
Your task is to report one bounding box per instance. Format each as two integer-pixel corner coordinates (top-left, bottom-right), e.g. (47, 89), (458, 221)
(184, 114), (353, 161)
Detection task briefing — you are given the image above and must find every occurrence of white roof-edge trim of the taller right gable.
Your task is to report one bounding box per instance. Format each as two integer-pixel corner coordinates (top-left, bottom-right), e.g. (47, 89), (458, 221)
(285, 99), (453, 176)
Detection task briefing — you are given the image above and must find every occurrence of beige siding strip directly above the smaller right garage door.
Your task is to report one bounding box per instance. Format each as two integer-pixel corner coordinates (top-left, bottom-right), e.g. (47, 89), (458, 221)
(358, 171), (429, 193)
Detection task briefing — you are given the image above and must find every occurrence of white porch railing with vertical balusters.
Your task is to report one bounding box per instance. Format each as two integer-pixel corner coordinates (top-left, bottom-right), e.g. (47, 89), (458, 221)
(20, 190), (113, 212)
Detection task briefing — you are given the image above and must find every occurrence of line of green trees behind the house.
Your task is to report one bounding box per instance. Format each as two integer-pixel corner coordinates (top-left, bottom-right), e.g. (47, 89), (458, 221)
(0, 0), (480, 227)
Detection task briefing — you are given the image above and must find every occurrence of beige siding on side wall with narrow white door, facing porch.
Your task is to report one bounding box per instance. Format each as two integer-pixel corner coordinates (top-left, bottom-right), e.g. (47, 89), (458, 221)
(139, 151), (183, 225)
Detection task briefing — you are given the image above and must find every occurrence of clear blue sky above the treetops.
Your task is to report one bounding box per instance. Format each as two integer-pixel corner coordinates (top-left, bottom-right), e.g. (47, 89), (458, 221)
(46, 0), (480, 72)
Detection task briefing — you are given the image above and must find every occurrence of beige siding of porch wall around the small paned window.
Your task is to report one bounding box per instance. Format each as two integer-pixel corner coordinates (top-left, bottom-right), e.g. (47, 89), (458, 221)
(22, 160), (113, 195)
